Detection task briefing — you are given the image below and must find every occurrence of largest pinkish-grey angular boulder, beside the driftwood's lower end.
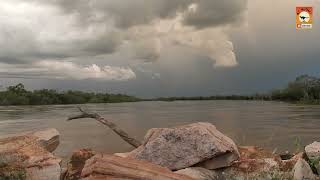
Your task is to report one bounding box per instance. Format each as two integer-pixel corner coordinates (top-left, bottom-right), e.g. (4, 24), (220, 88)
(128, 123), (239, 170)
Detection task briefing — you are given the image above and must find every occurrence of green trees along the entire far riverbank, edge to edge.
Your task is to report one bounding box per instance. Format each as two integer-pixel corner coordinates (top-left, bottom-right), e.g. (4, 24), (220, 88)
(0, 75), (320, 105)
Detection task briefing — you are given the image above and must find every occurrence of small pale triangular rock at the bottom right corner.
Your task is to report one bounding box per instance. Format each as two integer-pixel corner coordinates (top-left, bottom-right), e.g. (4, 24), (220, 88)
(293, 159), (316, 180)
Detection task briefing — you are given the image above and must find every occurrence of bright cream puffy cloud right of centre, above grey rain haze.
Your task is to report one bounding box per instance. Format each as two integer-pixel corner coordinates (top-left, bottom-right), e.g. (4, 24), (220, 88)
(127, 14), (238, 67)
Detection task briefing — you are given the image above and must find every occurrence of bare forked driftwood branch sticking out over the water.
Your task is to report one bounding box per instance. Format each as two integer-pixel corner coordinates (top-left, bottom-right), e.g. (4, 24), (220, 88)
(68, 107), (141, 148)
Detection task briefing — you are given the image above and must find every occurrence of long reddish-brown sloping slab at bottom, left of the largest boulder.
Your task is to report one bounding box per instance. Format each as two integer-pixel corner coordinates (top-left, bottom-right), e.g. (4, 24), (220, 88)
(81, 154), (193, 180)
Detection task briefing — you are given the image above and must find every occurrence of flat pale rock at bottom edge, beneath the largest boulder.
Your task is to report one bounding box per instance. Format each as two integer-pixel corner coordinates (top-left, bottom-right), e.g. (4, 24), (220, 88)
(175, 167), (221, 180)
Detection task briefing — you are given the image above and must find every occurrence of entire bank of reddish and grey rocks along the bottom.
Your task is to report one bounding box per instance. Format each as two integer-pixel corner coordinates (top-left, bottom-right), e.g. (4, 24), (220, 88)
(0, 123), (320, 180)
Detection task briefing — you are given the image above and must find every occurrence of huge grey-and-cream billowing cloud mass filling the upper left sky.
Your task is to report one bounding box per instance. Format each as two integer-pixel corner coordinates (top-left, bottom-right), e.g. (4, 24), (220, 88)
(0, 0), (247, 80)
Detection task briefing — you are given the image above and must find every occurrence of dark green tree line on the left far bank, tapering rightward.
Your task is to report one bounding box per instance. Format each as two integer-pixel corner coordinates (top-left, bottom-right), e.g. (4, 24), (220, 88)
(0, 84), (140, 106)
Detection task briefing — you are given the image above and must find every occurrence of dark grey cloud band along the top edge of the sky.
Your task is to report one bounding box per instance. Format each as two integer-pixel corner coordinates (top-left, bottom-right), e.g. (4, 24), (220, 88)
(38, 0), (247, 28)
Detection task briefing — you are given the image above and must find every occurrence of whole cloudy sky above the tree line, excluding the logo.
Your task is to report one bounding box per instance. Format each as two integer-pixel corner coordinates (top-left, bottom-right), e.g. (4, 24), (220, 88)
(0, 0), (320, 97)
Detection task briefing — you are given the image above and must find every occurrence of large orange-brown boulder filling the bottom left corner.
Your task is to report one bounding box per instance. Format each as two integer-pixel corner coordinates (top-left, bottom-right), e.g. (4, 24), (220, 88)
(0, 129), (61, 180)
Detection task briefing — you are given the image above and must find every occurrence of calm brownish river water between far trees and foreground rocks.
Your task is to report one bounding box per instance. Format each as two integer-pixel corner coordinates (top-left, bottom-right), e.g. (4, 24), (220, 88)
(0, 101), (320, 158)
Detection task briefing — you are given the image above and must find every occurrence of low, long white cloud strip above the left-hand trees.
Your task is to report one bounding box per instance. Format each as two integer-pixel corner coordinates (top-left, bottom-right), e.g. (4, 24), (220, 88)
(0, 61), (136, 81)
